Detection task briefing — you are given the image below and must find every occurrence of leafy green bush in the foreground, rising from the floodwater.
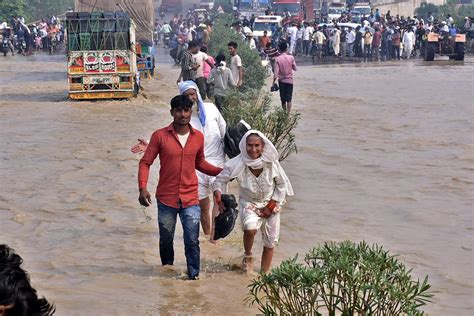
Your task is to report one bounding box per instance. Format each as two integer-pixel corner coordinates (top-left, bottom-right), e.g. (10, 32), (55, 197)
(248, 241), (433, 316)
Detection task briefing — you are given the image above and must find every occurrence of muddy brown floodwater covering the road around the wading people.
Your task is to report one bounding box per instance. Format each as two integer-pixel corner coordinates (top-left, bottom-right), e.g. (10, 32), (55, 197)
(0, 54), (474, 315)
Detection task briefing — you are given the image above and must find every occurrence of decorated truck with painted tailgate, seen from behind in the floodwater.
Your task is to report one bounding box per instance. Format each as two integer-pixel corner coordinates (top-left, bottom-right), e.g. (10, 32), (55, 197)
(66, 11), (139, 99)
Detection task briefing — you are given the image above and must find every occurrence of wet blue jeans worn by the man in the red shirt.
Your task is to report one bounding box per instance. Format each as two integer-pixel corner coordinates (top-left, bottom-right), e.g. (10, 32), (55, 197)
(157, 201), (201, 279)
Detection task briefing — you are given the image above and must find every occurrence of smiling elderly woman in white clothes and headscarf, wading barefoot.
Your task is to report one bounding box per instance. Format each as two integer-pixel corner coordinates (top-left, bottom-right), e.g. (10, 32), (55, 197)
(213, 130), (293, 272)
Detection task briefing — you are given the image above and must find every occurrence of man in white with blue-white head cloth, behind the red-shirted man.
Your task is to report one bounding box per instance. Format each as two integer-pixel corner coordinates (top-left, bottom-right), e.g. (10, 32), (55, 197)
(131, 80), (226, 235)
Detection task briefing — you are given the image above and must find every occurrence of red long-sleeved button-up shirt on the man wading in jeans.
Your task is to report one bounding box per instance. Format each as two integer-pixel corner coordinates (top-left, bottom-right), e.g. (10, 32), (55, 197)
(138, 124), (222, 208)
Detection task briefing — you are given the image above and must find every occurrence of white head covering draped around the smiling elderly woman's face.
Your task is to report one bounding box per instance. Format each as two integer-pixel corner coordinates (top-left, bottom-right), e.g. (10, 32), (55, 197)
(226, 129), (294, 196)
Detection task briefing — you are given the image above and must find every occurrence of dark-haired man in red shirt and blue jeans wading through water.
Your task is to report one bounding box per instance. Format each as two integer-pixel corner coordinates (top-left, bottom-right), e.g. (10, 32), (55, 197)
(138, 95), (222, 280)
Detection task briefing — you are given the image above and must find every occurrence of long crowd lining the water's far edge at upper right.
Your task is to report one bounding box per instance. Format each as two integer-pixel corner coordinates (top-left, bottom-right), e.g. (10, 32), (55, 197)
(229, 9), (472, 61)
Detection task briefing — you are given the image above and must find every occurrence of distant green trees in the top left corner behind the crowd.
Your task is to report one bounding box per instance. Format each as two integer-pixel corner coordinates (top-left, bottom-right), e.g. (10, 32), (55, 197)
(0, 0), (74, 22)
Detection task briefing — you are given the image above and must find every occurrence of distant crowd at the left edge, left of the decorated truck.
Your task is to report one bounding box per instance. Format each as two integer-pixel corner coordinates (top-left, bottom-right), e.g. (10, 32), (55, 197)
(0, 16), (65, 55)
